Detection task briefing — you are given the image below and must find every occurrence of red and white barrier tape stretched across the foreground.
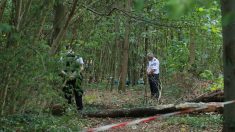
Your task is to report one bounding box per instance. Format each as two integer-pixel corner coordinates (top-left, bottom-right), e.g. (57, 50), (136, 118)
(84, 100), (235, 132)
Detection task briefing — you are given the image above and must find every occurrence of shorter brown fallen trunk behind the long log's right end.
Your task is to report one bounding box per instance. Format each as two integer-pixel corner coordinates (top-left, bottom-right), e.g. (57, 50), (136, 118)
(187, 90), (224, 102)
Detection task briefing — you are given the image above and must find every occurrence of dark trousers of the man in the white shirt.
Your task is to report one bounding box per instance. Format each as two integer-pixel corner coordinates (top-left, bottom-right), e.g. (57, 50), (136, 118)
(148, 74), (160, 98)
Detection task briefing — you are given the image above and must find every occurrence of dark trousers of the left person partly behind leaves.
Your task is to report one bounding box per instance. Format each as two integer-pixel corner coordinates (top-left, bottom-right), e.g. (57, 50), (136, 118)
(63, 79), (83, 110)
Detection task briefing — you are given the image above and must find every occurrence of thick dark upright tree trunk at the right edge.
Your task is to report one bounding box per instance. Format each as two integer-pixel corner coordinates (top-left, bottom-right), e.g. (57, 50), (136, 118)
(221, 0), (235, 132)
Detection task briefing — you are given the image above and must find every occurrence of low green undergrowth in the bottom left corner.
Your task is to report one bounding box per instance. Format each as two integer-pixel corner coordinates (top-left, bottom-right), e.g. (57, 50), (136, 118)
(0, 112), (87, 131)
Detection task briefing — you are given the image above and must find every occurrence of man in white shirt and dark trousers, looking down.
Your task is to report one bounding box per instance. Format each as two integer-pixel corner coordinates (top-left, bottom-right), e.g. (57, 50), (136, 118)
(147, 53), (160, 100)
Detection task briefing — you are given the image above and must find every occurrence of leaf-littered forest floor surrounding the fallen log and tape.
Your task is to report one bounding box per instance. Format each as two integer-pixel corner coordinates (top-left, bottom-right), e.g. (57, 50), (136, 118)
(0, 78), (222, 132)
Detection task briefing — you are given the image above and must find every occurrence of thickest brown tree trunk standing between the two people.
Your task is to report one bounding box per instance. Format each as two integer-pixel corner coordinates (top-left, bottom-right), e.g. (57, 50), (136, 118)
(118, 0), (131, 91)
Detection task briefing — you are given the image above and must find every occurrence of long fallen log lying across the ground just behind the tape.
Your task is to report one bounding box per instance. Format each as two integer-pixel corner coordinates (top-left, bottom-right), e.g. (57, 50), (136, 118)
(83, 103), (223, 118)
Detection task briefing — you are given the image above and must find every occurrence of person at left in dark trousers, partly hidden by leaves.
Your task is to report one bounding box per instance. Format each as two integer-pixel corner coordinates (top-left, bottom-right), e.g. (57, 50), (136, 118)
(62, 50), (84, 110)
